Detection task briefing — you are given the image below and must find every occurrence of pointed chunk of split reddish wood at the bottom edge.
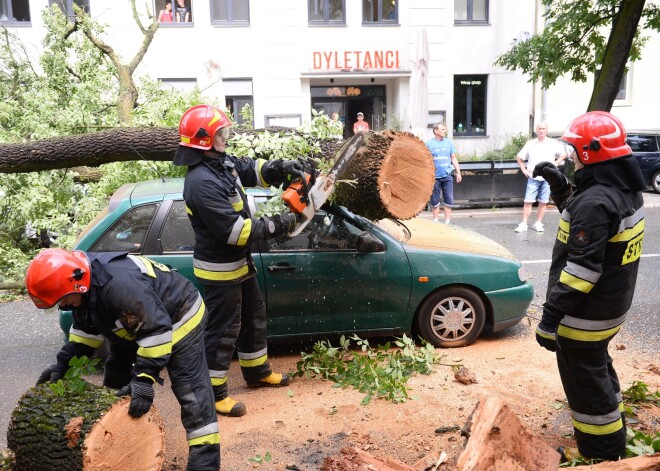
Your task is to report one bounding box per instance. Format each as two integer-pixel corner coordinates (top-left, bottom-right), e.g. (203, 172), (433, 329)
(456, 397), (560, 471)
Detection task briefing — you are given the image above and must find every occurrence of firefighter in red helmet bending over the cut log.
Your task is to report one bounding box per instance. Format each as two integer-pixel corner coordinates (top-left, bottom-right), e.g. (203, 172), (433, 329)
(25, 248), (220, 470)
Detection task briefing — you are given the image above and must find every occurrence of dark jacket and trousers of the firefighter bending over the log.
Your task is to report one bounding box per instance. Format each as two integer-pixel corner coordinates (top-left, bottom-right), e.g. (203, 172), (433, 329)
(57, 253), (220, 470)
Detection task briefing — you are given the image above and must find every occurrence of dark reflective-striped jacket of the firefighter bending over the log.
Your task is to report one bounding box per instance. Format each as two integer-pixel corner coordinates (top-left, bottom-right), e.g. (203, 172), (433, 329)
(58, 252), (204, 380)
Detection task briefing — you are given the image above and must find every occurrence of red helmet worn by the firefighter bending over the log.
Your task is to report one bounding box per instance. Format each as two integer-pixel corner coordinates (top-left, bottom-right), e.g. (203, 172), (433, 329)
(25, 249), (92, 309)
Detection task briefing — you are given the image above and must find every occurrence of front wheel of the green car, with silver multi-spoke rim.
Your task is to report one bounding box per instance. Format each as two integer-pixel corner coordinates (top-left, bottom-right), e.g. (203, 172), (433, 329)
(417, 287), (486, 348)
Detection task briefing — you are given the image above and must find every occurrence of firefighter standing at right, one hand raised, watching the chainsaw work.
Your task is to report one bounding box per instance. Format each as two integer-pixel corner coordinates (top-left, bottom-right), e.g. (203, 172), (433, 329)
(534, 111), (646, 460)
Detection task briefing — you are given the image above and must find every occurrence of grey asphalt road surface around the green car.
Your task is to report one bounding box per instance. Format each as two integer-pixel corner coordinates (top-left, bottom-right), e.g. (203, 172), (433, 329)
(0, 193), (660, 450)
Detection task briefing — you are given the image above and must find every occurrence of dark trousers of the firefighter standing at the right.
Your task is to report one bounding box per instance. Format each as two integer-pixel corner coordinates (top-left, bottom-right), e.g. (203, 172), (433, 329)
(557, 336), (626, 460)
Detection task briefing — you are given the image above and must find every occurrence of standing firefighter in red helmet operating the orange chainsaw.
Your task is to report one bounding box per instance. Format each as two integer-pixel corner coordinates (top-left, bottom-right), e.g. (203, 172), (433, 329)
(174, 105), (302, 417)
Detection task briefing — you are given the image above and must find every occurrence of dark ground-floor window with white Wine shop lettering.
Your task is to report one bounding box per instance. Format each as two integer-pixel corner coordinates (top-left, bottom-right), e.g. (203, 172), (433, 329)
(454, 75), (488, 137)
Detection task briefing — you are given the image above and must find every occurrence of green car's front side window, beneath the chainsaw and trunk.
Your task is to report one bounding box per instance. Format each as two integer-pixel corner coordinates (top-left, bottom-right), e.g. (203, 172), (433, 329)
(268, 211), (364, 252)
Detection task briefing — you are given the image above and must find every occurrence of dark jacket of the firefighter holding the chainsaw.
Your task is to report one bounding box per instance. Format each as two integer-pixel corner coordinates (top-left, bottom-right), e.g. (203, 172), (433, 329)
(183, 153), (278, 285)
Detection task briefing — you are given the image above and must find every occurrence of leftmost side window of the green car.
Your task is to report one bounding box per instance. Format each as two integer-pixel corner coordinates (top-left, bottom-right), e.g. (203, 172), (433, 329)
(89, 204), (159, 253)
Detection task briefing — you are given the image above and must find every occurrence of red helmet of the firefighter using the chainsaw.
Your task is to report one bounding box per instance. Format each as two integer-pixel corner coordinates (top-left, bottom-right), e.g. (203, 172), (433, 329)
(179, 105), (231, 150)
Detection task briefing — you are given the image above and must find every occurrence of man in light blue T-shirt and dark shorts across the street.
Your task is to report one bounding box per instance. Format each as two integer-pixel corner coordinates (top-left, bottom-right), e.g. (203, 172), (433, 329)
(426, 123), (463, 224)
